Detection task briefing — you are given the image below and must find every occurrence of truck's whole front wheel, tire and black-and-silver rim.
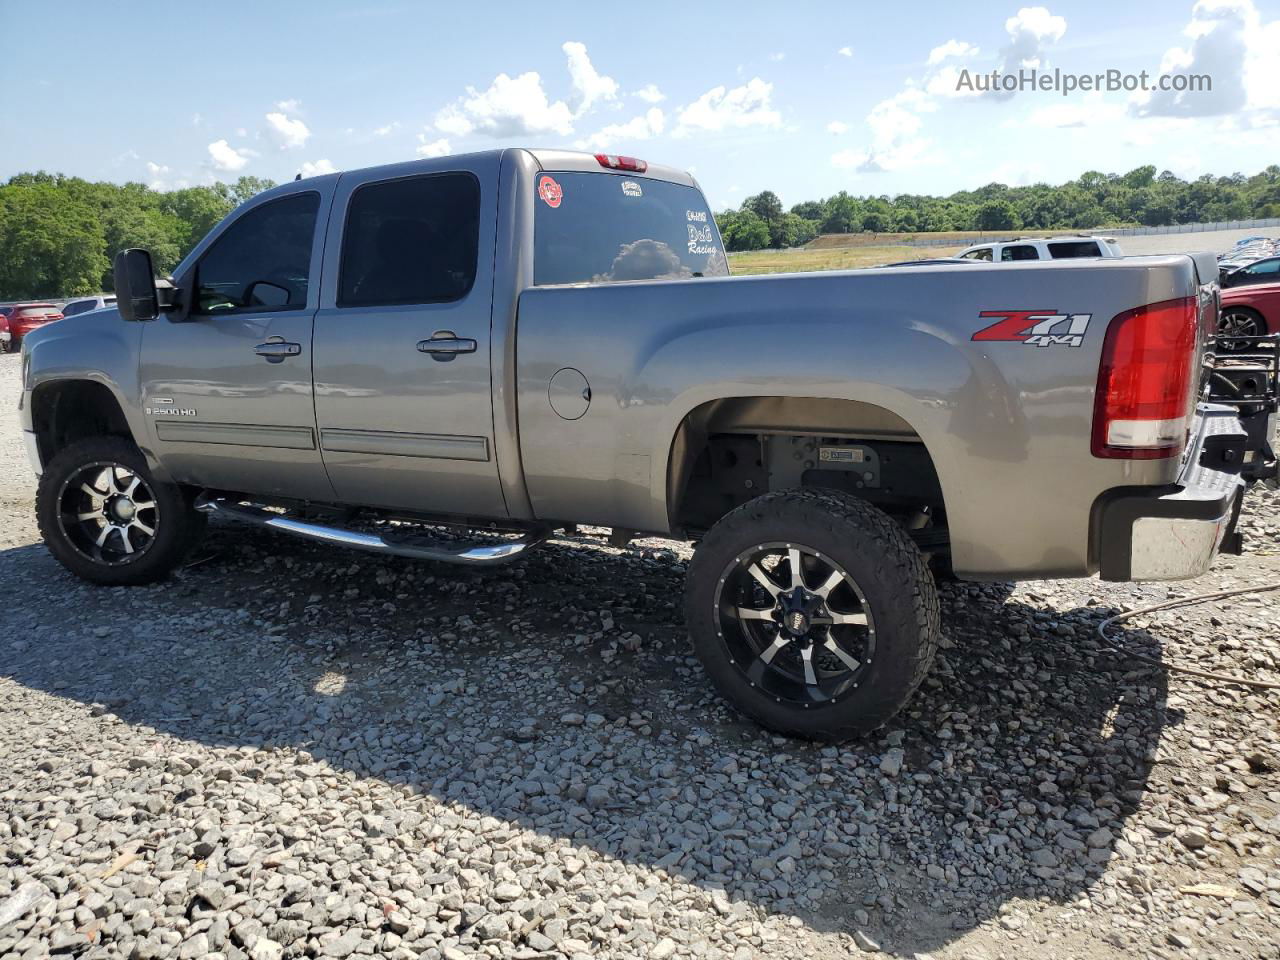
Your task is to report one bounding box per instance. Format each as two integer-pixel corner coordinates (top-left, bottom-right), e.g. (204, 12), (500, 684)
(36, 436), (205, 586)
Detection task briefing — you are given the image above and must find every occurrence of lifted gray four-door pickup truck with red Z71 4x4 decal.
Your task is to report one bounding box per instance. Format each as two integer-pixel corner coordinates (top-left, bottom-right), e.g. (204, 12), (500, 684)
(22, 148), (1270, 739)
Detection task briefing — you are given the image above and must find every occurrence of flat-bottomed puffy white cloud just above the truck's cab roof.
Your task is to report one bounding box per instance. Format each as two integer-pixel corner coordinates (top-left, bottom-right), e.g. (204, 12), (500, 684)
(435, 72), (573, 137)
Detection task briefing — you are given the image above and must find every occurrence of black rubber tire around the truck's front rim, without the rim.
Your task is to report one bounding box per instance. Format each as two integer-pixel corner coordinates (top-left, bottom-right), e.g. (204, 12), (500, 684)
(36, 436), (206, 586)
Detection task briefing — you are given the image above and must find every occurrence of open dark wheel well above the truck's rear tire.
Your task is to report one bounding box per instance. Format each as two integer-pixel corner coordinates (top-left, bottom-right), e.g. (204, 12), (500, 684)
(667, 397), (946, 535)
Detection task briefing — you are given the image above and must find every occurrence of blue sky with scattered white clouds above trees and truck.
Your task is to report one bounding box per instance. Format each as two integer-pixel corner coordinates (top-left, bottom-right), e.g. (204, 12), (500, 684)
(0, 0), (1280, 209)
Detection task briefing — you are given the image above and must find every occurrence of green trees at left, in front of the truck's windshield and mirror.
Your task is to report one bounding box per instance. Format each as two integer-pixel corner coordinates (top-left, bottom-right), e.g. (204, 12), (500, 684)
(0, 173), (275, 301)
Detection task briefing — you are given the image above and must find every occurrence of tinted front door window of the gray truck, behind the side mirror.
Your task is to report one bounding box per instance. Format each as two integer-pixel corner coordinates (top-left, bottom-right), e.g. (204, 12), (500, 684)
(193, 192), (320, 314)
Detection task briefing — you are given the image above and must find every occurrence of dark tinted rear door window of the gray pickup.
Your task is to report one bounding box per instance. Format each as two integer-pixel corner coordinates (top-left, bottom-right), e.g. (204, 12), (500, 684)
(338, 173), (480, 307)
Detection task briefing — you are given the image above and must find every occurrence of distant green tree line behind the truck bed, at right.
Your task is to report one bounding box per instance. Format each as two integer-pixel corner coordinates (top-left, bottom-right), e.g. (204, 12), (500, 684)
(716, 164), (1280, 251)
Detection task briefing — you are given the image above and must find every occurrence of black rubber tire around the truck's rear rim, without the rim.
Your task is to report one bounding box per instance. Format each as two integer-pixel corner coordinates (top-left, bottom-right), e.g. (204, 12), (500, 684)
(685, 488), (940, 741)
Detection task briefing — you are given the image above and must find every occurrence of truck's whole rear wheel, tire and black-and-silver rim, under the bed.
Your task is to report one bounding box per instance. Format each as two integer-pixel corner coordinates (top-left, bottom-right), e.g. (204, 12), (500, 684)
(685, 489), (940, 741)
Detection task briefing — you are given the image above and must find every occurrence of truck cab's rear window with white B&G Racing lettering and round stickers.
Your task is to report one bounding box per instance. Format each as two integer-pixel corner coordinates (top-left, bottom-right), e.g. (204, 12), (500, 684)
(534, 173), (728, 285)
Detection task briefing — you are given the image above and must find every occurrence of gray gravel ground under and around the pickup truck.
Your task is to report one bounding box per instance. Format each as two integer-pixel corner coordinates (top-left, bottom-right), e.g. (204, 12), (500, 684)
(0, 356), (1280, 960)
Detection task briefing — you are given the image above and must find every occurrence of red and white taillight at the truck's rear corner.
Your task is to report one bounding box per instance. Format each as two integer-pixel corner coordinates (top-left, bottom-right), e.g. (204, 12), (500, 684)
(1093, 297), (1198, 460)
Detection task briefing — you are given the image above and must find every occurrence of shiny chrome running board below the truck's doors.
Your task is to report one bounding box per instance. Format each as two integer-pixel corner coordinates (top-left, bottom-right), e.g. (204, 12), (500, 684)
(195, 494), (550, 567)
